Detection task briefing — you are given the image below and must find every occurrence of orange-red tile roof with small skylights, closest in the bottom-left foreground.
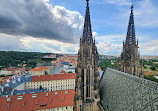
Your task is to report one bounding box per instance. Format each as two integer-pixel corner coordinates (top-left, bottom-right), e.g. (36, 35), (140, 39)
(0, 89), (75, 111)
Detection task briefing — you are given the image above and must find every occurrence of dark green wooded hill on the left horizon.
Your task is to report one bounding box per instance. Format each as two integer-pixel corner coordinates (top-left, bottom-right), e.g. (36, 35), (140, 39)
(0, 51), (52, 68)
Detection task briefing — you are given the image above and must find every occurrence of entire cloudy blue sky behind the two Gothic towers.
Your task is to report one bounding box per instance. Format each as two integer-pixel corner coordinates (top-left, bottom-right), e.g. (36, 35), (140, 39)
(0, 0), (158, 55)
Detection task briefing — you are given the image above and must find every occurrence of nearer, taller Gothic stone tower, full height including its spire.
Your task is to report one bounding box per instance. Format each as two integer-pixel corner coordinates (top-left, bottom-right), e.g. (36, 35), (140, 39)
(74, 0), (100, 111)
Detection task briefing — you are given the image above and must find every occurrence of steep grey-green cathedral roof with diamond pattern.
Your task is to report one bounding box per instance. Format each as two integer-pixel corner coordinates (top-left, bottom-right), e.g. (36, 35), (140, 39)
(100, 68), (158, 111)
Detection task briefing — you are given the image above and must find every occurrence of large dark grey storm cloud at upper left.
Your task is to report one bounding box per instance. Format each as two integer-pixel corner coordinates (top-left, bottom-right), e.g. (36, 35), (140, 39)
(0, 0), (81, 42)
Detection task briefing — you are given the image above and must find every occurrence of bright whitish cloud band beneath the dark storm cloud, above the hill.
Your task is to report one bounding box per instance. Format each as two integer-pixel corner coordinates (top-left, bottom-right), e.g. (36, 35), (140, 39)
(0, 33), (79, 54)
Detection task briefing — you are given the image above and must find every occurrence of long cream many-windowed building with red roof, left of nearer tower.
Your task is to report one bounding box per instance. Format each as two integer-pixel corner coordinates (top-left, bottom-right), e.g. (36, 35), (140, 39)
(25, 73), (76, 91)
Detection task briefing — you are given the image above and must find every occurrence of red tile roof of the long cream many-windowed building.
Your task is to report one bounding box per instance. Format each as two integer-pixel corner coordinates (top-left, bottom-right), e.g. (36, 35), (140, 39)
(31, 73), (76, 82)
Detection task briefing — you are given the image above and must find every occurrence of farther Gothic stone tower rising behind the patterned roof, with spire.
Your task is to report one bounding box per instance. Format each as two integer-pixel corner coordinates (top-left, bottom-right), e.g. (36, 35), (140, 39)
(118, 5), (143, 77)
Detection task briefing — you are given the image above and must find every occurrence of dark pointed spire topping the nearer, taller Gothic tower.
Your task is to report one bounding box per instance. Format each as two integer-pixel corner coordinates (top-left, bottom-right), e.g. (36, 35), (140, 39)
(83, 0), (92, 39)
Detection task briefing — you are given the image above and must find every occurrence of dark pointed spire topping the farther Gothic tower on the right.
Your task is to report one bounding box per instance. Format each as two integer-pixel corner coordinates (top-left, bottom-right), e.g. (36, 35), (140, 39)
(126, 5), (136, 45)
